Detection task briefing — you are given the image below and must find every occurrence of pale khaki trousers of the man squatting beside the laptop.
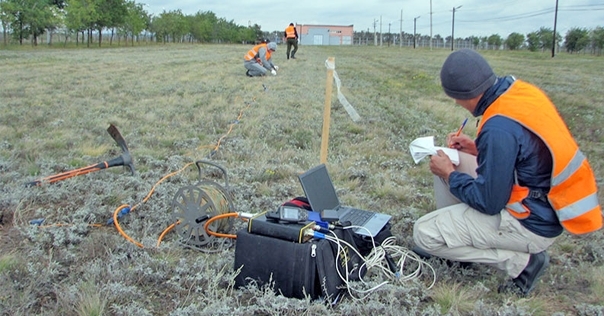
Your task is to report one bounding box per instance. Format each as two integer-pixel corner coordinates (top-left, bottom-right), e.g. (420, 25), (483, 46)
(413, 153), (555, 278)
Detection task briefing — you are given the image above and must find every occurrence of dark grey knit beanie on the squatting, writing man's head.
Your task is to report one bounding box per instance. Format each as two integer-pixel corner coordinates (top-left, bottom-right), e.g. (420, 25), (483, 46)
(440, 49), (497, 100)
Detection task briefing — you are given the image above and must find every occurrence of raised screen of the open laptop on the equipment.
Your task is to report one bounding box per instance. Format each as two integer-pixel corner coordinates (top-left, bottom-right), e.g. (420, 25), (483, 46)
(298, 164), (340, 212)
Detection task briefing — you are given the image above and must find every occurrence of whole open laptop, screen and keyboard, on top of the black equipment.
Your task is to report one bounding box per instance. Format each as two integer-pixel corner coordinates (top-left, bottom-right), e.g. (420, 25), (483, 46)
(298, 164), (392, 237)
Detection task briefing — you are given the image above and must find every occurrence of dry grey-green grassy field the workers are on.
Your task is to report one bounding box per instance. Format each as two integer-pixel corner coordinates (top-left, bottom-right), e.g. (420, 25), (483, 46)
(0, 45), (604, 315)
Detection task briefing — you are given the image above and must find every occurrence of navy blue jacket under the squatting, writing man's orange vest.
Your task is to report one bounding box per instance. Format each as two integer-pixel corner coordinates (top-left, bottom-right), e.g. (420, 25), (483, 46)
(449, 76), (563, 237)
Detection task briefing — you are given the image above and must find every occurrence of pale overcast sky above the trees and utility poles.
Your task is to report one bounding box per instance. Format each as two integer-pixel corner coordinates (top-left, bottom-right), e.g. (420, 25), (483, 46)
(141, 0), (604, 38)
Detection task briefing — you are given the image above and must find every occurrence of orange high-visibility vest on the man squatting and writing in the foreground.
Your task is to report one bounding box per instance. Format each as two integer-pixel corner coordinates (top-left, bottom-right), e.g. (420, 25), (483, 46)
(478, 80), (602, 234)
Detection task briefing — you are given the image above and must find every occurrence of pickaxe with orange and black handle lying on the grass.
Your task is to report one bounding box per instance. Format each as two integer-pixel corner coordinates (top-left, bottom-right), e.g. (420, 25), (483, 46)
(26, 124), (136, 186)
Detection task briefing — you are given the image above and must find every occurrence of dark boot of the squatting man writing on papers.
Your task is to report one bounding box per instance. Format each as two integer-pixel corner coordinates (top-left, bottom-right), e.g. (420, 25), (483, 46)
(498, 251), (549, 296)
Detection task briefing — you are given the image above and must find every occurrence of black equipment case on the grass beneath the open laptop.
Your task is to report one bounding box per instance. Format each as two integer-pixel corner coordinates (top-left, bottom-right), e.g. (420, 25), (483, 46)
(234, 229), (352, 301)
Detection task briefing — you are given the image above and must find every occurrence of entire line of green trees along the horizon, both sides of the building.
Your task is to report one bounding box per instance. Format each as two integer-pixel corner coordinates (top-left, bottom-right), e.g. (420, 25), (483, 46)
(0, 0), (604, 55)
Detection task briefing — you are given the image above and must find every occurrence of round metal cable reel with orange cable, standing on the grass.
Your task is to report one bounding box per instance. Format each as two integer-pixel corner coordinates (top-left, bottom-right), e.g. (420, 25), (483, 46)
(172, 160), (235, 252)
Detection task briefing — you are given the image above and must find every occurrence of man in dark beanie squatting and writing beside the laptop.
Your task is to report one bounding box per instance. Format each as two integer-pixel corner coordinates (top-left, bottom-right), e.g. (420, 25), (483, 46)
(413, 49), (602, 296)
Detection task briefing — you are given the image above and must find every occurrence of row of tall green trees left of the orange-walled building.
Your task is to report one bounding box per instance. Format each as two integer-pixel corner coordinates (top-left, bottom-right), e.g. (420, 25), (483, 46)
(0, 0), (263, 46)
